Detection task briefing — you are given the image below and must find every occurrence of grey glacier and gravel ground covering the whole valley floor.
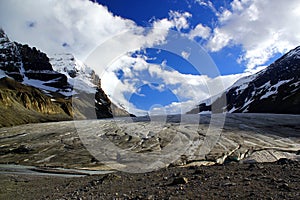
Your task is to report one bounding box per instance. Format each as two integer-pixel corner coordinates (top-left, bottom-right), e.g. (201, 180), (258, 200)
(0, 114), (300, 199)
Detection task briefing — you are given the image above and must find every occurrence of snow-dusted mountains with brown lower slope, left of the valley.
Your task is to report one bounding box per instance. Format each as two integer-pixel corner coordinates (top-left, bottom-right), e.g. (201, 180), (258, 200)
(0, 29), (129, 127)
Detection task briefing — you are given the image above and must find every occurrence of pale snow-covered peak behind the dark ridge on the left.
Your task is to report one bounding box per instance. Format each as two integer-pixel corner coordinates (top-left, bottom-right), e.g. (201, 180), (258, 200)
(50, 53), (130, 118)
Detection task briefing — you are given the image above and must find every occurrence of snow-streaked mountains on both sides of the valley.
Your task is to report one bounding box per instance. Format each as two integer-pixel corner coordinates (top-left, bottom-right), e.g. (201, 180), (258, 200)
(0, 29), (300, 127)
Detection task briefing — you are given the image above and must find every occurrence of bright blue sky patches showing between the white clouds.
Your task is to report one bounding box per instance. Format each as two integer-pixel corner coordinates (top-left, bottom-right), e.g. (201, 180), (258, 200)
(97, 0), (245, 110)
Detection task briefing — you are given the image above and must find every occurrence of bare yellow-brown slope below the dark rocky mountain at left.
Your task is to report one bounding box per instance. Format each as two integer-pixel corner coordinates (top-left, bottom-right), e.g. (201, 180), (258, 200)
(0, 77), (73, 127)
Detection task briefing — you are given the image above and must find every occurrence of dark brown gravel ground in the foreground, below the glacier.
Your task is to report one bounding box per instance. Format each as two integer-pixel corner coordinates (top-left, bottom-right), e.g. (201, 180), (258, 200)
(0, 159), (300, 200)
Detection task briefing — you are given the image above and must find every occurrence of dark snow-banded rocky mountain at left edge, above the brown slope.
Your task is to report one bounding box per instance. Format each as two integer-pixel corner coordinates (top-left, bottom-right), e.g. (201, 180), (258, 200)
(0, 29), (72, 96)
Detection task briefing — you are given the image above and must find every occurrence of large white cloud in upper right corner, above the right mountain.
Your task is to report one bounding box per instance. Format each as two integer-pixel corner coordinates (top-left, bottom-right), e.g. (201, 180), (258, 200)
(207, 0), (300, 71)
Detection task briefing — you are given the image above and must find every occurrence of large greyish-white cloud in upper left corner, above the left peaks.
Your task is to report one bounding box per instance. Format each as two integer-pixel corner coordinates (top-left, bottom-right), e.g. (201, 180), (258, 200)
(0, 0), (136, 59)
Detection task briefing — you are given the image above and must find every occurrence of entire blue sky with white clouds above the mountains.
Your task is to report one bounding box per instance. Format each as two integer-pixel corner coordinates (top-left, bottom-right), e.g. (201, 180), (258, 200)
(0, 0), (300, 114)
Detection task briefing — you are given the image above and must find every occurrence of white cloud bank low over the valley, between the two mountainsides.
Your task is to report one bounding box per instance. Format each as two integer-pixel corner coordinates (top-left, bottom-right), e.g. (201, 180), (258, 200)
(103, 55), (245, 114)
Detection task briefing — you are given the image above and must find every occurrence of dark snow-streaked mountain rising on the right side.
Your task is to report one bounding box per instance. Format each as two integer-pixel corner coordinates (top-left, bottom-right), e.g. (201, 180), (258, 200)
(188, 46), (300, 114)
